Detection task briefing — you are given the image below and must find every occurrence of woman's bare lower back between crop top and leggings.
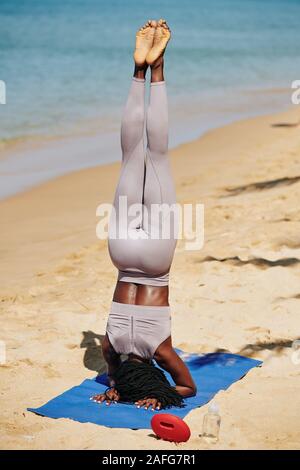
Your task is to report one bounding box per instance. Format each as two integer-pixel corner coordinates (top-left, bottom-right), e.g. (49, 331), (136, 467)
(113, 281), (169, 306)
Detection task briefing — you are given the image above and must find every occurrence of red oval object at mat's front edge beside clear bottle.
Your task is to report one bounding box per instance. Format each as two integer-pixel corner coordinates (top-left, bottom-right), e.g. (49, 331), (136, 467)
(151, 413), (191, 442)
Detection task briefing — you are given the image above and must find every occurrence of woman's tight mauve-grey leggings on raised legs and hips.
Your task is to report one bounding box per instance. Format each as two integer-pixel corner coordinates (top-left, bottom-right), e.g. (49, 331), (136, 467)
(108, 77), (177, 286)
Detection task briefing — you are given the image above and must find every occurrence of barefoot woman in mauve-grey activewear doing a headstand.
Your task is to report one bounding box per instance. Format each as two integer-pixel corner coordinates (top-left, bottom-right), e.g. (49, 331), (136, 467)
(92, 19), (196, 410)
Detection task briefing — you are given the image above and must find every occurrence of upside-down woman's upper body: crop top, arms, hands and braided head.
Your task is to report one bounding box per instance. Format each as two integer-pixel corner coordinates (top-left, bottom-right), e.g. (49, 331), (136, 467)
(93, 302), (196, 410)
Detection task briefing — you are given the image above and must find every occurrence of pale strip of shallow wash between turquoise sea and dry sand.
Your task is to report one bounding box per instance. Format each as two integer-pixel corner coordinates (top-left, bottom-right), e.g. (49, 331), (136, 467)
(0, 84), (290, 200)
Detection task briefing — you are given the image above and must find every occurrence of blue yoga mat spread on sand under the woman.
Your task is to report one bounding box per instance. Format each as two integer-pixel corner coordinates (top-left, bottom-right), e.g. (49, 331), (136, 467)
(28, 350), (261, 429)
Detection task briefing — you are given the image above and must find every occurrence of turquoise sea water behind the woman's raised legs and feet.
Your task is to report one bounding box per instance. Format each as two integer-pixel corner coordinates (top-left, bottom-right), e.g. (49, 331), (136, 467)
(0, 0), (300, 196)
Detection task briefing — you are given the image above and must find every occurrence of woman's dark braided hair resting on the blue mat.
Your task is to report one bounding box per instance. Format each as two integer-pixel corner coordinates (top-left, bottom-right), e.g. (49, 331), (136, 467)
(113, 360), (184, 408)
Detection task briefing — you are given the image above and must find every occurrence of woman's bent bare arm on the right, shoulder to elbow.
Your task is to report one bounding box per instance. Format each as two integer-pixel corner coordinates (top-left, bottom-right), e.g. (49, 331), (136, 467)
(154, 337), (197, 398)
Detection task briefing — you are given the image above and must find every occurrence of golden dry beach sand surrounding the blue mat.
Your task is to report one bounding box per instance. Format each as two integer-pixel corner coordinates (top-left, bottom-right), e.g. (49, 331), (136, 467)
(0, 107), (300, 450)
